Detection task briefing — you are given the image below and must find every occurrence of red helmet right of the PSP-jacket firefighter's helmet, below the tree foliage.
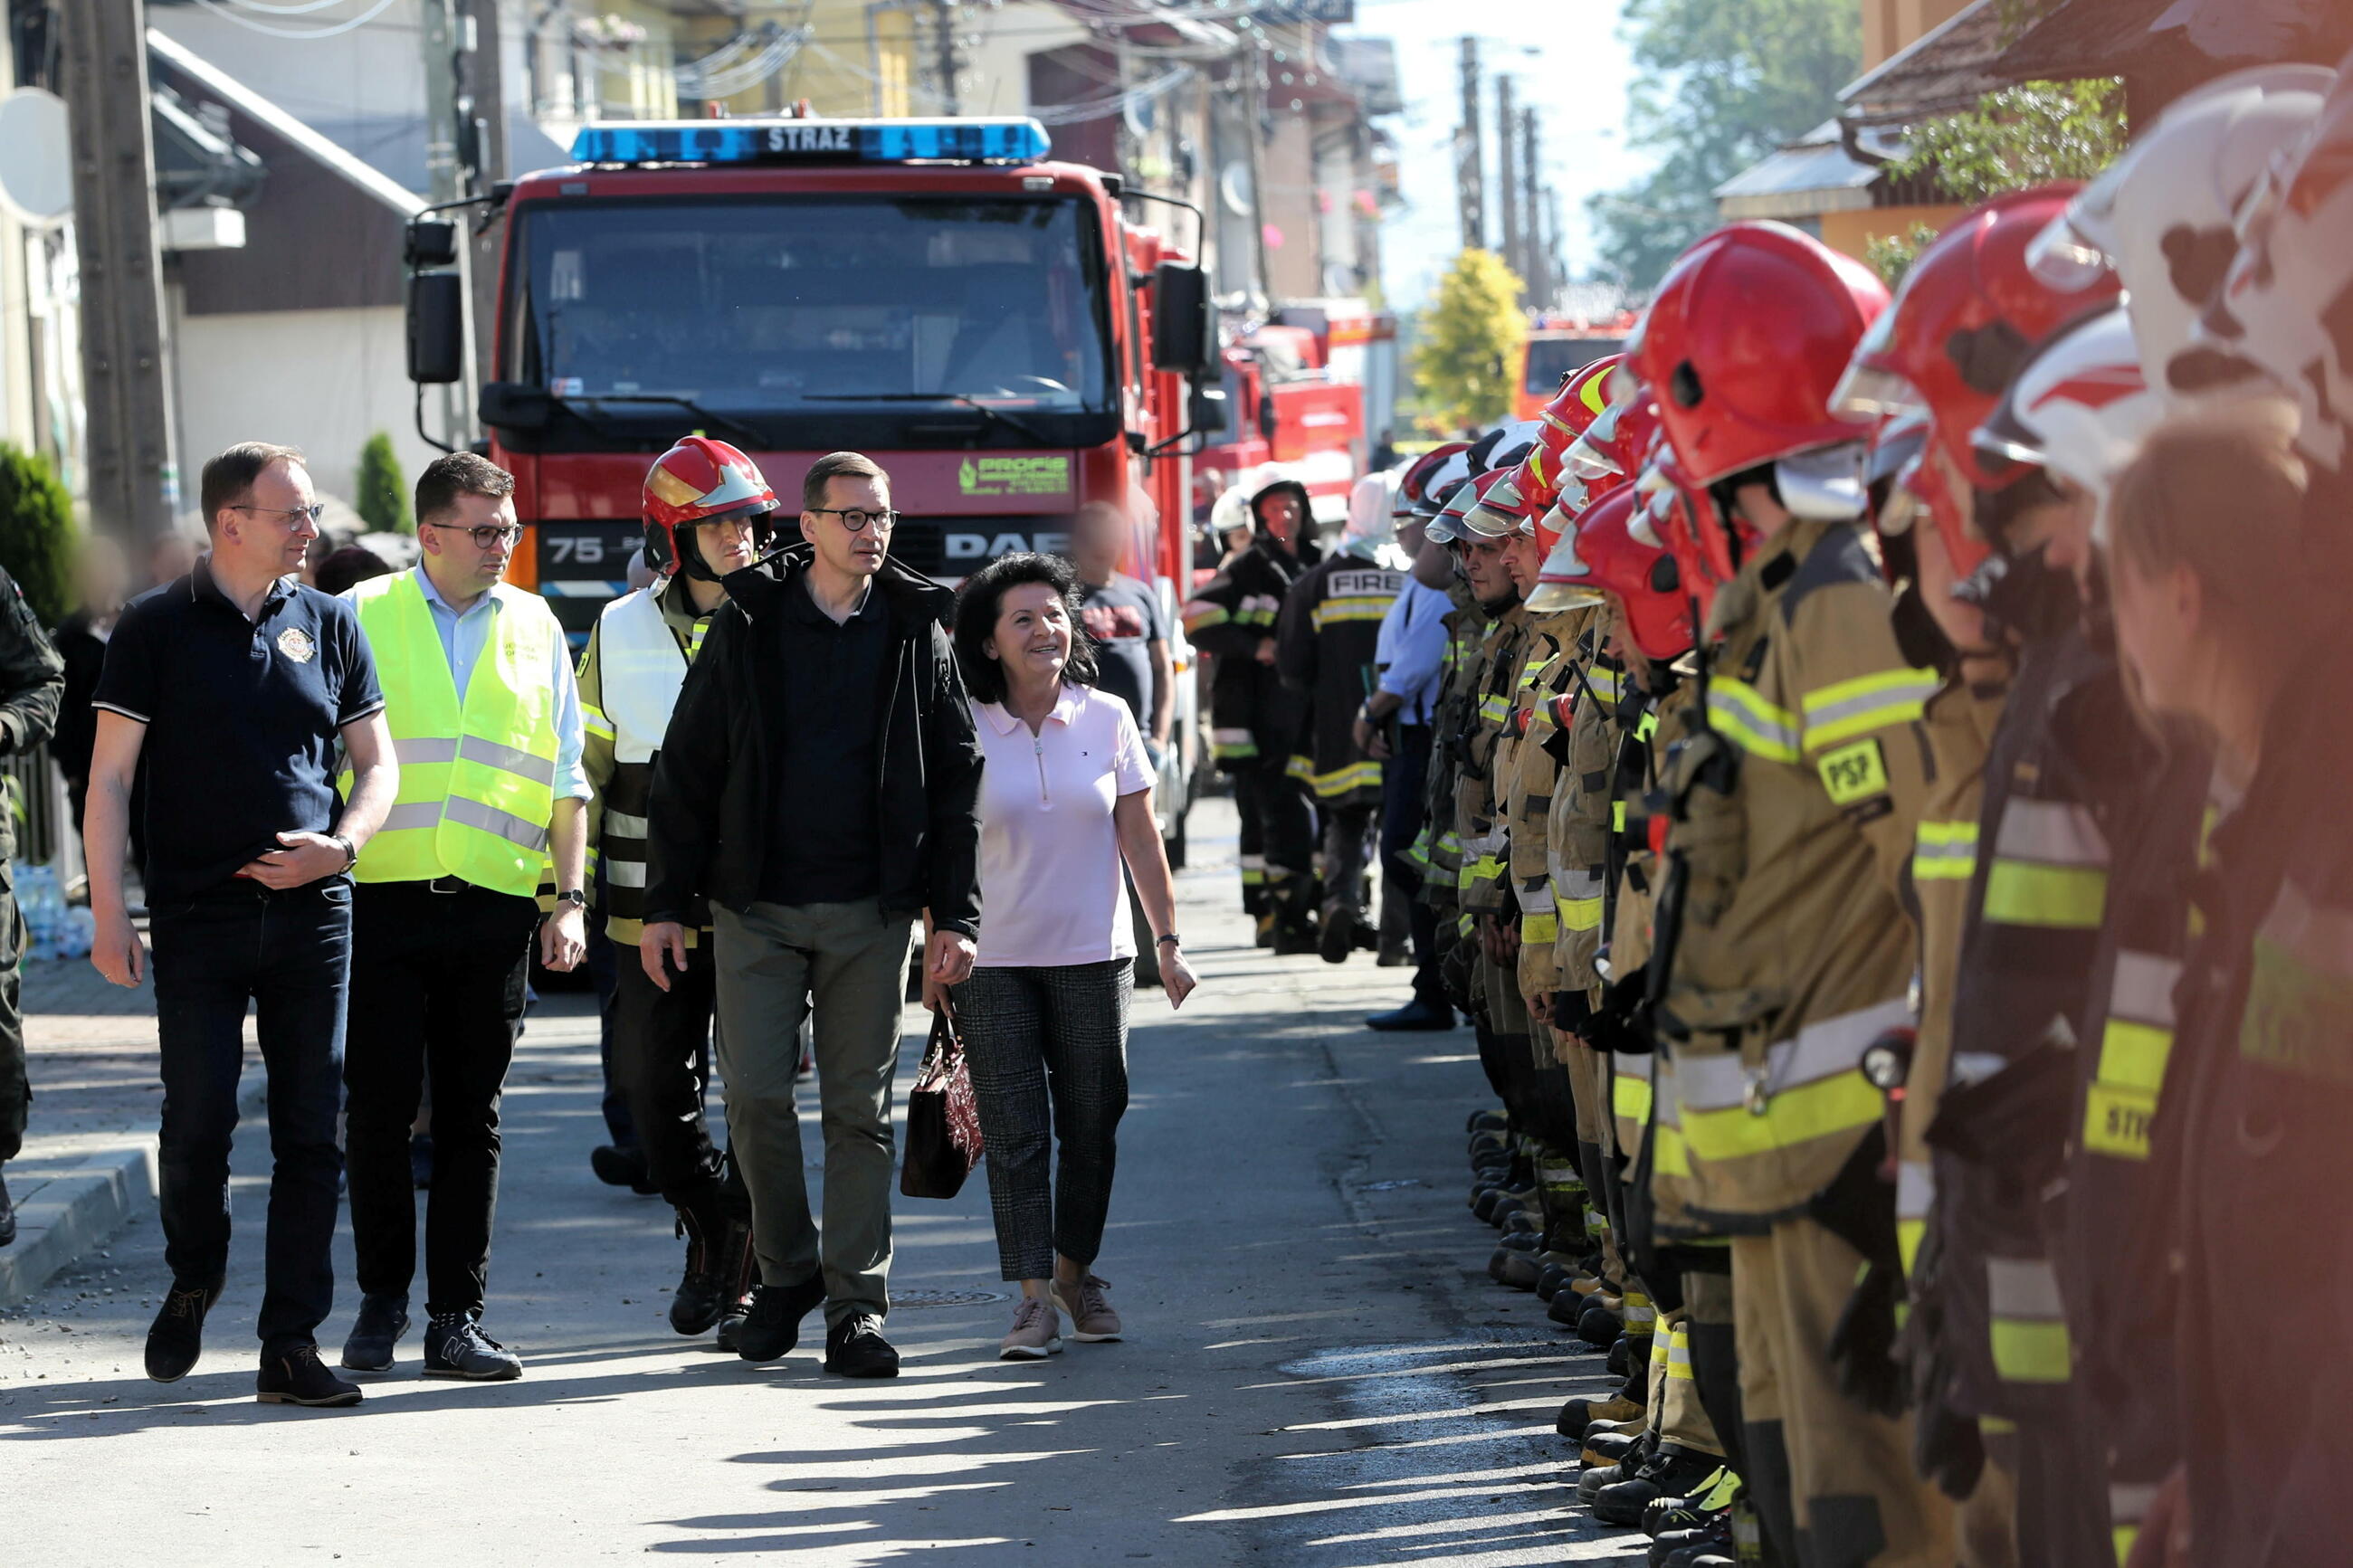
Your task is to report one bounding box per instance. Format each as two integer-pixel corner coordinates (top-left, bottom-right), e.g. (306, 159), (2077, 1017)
(1831, 184), (2120, 489)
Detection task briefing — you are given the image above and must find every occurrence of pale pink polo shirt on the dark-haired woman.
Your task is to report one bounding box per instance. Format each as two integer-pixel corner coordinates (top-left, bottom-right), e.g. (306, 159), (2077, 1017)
(972, 687), (1153, 968)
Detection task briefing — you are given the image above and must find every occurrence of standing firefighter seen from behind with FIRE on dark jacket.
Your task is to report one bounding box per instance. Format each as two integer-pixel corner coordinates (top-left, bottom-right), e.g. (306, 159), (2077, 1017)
(1275, 472), (1407, 964)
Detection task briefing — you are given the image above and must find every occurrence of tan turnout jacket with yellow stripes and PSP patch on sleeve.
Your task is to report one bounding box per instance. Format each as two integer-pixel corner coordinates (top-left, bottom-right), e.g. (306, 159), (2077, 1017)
(1659, 519), (1937, 1222)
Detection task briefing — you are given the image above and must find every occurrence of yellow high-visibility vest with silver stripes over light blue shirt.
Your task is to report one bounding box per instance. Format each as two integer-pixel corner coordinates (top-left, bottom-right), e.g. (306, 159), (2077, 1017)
(344, 571), (565, 898)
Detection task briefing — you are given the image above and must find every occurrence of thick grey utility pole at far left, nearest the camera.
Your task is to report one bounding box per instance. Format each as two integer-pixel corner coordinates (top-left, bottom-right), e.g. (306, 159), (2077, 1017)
(59, 0), (179, 541)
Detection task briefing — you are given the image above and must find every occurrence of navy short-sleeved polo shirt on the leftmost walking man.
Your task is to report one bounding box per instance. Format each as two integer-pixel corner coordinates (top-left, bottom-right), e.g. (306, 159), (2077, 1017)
(90, 562), (384, 908)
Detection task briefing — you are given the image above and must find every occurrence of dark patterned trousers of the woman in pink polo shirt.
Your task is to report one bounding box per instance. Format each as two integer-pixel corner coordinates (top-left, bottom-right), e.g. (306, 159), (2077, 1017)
(956, 959), (1129, 1278)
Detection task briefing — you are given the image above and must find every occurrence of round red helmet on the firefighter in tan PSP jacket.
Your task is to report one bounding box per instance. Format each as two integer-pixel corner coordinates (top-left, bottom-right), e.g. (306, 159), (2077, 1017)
(1624, 223), (1887, 487)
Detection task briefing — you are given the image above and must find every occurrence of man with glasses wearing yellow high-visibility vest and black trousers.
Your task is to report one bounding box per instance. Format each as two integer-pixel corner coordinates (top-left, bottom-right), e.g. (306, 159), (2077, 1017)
(344, 451), (588, 1380)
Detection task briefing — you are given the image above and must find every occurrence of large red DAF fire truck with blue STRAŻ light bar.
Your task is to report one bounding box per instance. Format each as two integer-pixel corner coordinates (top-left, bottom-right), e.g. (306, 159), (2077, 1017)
(407, 113), (1224, 846)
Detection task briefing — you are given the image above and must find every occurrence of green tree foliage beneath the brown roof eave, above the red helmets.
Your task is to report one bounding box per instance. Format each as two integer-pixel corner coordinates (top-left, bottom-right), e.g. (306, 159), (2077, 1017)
(1887, 80), (2125, 207)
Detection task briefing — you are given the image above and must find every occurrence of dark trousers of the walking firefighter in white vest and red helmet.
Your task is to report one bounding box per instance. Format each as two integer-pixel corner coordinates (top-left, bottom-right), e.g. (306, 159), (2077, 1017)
(612, 931), (719, 1203)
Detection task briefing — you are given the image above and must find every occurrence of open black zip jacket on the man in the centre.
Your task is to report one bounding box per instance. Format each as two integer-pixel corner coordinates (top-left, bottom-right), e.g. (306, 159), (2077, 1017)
(644, 543), (981, 936)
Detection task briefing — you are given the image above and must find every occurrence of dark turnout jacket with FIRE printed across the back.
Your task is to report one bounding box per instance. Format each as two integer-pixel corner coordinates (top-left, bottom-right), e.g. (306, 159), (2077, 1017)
(1275, 555), (1405, 806)
